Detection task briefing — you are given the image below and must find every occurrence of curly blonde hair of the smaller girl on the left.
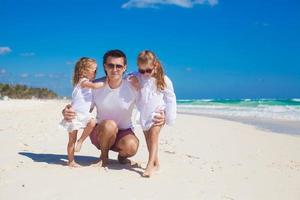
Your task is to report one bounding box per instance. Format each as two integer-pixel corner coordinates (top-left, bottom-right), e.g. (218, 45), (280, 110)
(73, 57), (96, 86)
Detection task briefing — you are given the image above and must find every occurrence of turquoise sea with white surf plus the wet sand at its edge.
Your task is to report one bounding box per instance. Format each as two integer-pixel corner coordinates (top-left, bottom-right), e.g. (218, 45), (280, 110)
(177, 98), (300, 135)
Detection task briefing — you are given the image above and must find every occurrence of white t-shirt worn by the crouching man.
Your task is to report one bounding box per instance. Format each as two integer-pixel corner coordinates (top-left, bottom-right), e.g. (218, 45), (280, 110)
(93, 79), (138, 130)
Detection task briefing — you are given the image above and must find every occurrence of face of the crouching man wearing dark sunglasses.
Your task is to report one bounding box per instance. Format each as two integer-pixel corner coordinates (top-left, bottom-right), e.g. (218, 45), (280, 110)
(104, 56), (126, 80)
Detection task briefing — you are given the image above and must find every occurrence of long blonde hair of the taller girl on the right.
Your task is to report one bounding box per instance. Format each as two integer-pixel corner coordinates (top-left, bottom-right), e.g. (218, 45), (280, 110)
(137, 50), (166, 90)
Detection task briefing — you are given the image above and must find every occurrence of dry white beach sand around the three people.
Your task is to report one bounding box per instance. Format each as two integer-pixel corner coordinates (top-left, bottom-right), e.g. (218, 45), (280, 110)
(0, 100), (300, 200)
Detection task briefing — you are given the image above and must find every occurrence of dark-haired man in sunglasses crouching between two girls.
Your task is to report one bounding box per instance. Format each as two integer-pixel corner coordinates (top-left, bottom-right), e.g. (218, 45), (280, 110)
(63, 50), (165, 167)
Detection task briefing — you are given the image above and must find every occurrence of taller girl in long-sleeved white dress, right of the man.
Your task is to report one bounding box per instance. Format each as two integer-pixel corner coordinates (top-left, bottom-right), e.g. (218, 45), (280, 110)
(130, 50), (176, 177)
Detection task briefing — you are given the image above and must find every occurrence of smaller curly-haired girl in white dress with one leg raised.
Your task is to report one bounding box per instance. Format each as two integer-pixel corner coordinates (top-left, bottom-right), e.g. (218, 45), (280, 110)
(61, 57), (104, 167)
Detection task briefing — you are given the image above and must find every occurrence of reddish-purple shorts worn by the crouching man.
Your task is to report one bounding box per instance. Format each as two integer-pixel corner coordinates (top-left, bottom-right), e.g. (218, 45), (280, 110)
(90, 124), (134, 152)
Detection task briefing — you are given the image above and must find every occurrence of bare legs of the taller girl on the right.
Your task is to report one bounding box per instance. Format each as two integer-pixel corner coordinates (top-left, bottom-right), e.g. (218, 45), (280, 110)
(143, 126), (161, 177)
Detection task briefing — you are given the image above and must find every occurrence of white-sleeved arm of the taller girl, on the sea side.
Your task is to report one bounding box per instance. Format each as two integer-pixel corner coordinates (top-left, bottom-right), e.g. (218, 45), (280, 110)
(163, 76), (177, 125)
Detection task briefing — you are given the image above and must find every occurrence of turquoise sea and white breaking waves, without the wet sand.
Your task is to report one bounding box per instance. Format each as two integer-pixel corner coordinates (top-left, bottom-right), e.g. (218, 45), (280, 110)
(177, 99), (300, 121)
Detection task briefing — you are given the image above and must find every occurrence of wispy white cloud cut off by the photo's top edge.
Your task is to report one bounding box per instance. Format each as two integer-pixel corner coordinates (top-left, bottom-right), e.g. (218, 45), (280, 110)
(122, 0), (219, 8)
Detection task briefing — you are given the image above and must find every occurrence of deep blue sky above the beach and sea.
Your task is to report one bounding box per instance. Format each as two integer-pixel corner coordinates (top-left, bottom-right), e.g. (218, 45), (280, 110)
(0, 0), (300, 99)
